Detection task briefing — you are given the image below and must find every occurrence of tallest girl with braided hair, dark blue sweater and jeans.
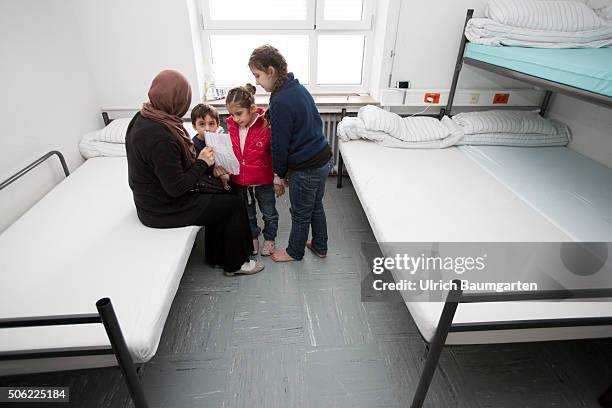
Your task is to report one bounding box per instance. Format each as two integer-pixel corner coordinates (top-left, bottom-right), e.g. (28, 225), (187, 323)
(249, 45), (332, 262)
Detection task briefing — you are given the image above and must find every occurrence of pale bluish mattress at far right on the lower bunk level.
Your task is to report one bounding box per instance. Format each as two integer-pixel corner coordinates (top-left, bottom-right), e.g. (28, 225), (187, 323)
(459, 146), (612, 242)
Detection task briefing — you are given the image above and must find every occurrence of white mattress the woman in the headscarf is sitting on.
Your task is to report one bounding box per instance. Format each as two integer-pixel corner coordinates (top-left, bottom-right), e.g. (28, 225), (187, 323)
(0, 157), (199, 374)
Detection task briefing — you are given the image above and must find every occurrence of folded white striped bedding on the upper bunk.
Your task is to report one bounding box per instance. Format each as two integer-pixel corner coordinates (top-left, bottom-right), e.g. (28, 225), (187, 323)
(465, 0), (612, 48)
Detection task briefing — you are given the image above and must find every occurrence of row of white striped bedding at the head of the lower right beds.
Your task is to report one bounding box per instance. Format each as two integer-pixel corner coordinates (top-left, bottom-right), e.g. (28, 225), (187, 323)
(338, 106), (570, 149)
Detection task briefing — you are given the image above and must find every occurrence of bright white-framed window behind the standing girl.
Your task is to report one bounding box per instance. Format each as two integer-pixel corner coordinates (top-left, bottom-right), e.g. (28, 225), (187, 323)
(200, 0), (373, 92)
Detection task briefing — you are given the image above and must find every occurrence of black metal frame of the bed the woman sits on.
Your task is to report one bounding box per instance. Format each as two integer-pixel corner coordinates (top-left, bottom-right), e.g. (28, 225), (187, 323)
(0, 150), (149, 408)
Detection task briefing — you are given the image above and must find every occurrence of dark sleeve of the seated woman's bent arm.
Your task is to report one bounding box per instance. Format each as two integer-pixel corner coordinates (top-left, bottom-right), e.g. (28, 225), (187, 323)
(151, 140), (208, 197)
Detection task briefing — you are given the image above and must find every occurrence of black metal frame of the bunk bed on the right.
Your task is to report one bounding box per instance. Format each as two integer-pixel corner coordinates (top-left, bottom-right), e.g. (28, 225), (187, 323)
(337, 9), (612, 408)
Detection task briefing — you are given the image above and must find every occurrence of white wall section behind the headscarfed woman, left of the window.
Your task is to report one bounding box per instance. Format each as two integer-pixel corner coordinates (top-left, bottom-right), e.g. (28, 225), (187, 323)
(72, 0), (201, 108)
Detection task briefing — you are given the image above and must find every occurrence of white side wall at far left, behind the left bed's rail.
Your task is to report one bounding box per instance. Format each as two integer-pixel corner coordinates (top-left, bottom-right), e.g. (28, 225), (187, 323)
(0, 0), (101, 233)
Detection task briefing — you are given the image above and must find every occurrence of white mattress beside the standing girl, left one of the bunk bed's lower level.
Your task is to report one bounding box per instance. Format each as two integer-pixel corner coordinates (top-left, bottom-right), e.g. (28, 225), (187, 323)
(340, 141), (612, 344)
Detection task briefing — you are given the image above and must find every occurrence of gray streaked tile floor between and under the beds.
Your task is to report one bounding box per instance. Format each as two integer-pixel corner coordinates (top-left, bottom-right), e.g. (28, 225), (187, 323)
(0, 179), (612, 408)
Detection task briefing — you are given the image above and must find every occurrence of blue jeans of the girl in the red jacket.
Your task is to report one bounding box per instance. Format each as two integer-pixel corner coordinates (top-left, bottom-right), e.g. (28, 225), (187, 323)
(240, 184), (278, 241)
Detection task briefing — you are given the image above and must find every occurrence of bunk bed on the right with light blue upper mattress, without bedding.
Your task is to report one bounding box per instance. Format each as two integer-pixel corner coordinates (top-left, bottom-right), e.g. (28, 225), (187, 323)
(338, 10), (612, 408)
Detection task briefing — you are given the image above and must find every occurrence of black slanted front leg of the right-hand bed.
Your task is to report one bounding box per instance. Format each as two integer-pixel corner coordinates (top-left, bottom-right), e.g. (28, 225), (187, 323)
(410, 280), (463, 408)
